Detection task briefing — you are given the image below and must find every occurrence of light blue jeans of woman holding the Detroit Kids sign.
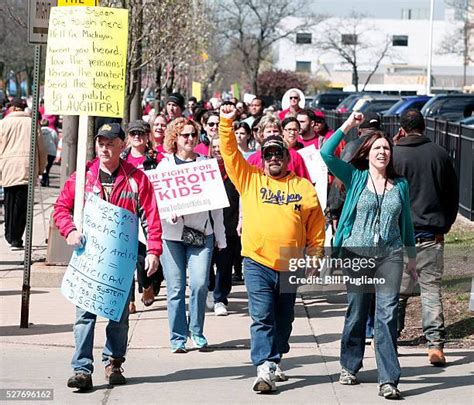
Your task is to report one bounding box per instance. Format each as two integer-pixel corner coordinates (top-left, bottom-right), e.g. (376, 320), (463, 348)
(160, 235), (214, 349)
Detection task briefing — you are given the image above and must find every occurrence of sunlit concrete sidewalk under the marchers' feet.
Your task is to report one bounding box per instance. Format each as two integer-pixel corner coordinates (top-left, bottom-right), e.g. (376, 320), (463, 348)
(0, 168), (474, 405)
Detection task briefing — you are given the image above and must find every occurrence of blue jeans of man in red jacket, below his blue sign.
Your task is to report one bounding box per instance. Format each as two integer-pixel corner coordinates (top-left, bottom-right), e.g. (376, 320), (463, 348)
(71, 296), (130, 374)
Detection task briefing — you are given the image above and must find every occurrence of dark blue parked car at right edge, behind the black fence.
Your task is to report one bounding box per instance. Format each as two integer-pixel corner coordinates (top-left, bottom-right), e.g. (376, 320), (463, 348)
(421, 94), (474, 121)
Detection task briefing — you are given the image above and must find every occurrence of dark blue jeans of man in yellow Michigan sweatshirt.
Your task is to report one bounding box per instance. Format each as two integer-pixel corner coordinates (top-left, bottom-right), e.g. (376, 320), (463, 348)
(243, 257), (296, 366)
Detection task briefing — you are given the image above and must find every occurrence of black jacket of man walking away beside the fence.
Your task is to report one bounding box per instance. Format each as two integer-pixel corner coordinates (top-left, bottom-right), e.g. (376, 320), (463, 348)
(393, 134), (459, 234)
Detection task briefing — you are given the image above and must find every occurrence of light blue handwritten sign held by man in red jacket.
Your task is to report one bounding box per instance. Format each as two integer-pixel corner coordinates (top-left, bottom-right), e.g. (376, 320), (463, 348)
(61, 196), (138, 321)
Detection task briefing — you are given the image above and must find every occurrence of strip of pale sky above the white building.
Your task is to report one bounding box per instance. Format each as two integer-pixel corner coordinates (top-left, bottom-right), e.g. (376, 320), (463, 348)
(309, 0), (444, 19)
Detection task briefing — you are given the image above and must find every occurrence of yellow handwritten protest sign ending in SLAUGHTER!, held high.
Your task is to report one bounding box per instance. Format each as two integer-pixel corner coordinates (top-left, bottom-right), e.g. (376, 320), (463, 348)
(44, 7), (128, 117)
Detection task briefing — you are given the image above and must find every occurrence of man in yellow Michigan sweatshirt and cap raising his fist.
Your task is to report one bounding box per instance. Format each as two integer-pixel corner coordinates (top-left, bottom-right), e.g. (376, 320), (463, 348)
(219, 105), (325, 392)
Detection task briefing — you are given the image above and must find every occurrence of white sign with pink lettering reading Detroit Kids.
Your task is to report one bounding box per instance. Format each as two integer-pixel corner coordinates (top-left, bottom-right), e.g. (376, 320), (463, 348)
(145, 159), (229, 219)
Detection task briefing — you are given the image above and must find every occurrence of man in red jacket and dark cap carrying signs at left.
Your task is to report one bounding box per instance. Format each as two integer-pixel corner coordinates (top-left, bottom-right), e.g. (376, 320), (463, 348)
(53, 123), (162, 391)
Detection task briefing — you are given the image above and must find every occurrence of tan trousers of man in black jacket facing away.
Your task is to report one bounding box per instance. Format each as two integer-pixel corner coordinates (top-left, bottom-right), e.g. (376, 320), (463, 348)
(398, 241), (446, 349)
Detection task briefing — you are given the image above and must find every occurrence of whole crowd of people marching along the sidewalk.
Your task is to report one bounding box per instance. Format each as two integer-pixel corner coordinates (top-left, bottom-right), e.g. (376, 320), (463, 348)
(0, 89), (459, 399)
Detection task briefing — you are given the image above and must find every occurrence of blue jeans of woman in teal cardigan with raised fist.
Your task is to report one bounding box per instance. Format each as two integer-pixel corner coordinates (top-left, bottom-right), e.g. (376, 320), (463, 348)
(341, 253), (403, 385)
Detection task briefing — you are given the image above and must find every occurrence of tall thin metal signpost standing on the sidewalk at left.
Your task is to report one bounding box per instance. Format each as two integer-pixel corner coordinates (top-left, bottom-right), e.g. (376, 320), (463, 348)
(20, 45), (41, 328)
